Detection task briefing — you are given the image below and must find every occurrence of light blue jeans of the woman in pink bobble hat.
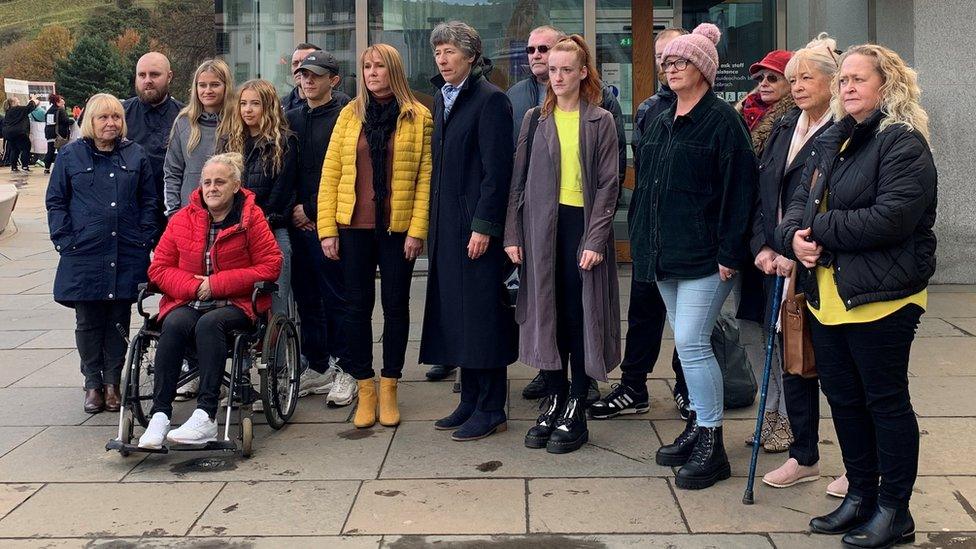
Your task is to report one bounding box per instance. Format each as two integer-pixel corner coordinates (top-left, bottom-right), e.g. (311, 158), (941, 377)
(657, 273), (732, 427)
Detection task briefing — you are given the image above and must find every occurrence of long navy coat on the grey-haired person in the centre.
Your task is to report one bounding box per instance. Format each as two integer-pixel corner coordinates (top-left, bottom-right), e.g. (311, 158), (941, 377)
(420, 62), (518, 368)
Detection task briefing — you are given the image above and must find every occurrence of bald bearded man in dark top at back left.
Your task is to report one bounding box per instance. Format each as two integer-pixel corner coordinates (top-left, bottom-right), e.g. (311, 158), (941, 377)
(122, 51), (183, 234)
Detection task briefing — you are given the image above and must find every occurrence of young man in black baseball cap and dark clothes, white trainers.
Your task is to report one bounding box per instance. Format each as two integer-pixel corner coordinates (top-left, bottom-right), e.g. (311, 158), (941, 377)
(285, 50), (357, 406)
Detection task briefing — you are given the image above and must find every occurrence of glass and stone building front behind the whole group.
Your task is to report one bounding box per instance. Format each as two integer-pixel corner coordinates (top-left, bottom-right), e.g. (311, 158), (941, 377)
(216, 0), (976, 283)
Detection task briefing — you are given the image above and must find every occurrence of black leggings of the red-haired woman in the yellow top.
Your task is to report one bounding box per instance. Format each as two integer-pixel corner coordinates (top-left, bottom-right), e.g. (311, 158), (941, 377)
(543, 204), (590, 398)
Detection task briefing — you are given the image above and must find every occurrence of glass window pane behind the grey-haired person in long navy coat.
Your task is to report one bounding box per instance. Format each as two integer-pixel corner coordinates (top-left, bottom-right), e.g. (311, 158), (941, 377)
(368, 0), (583, 95)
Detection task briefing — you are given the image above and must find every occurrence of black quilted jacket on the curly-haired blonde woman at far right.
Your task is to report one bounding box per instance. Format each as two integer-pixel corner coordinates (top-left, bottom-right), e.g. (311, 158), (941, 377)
(775, 111), (938, 310)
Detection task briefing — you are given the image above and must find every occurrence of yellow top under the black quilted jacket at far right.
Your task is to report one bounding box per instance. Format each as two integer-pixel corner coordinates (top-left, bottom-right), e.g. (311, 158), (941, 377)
(807, 142), (929, 326)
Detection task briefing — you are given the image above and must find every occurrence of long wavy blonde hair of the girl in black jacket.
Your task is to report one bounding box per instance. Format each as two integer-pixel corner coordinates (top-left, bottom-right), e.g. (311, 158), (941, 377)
(216, 79), (288, 176)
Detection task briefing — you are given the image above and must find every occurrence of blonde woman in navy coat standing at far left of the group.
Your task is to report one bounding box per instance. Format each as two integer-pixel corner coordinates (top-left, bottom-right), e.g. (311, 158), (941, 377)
(47, 93), (157, 414)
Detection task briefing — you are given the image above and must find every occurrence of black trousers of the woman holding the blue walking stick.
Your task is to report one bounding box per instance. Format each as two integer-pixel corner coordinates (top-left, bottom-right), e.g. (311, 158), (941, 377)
(783, 372), (820, 466)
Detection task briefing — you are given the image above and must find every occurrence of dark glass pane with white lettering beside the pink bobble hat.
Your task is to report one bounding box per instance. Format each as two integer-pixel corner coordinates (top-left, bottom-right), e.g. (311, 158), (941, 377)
(681, 0), (776, 103)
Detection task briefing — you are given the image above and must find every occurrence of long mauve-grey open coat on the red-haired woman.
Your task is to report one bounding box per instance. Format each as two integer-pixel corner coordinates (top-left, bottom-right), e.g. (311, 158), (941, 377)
(505, 102), (620, 381)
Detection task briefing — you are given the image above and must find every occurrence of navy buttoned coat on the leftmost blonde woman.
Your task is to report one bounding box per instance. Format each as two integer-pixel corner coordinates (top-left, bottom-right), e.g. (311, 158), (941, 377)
(47, 139), (157, 307)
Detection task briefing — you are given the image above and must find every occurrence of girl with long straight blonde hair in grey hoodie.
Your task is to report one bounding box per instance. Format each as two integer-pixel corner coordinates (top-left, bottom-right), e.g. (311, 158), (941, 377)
(163, 58), (234, 216)
